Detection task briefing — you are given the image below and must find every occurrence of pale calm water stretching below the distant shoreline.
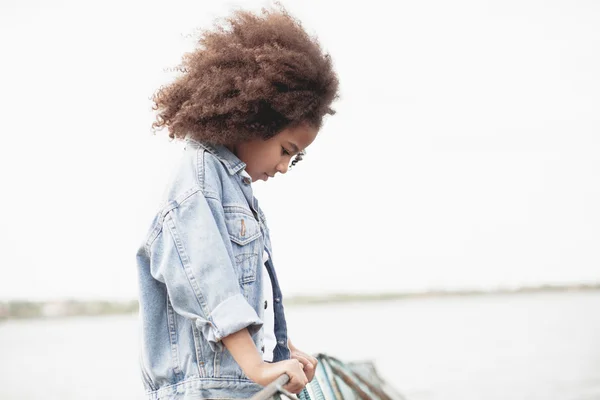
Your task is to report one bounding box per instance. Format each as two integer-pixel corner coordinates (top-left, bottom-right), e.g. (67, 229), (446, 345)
(0, 292), (600, 400)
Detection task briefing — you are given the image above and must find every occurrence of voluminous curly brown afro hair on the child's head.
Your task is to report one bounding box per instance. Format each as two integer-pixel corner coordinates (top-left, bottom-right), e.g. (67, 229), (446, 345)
(152, 6), (338, 145)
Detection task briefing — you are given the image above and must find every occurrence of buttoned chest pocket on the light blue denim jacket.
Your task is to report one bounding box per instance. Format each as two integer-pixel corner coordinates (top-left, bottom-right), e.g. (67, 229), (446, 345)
(225, 211), (261, 284)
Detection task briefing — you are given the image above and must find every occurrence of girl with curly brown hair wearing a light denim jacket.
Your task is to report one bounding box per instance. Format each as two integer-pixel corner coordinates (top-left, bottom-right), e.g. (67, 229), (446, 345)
(137, 3), (338, 399)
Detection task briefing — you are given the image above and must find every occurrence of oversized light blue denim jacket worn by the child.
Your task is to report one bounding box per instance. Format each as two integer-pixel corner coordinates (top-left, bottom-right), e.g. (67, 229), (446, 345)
(137, 138), (290, 400)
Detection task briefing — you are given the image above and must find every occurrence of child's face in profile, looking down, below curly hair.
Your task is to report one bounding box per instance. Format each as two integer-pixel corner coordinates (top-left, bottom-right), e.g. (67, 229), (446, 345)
(232, 125), (318, 182)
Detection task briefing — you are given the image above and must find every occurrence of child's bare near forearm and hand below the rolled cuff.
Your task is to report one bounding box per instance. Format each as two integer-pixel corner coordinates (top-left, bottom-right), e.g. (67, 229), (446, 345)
(223, 329), (308, 393)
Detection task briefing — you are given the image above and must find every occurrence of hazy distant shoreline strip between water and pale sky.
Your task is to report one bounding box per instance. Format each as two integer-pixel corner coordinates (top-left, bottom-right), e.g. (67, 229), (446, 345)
(0, 282), (600, 321)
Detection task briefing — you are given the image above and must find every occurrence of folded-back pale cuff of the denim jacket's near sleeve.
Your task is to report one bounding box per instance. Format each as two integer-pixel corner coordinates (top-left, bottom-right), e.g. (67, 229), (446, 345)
(196, 293), (263, 351)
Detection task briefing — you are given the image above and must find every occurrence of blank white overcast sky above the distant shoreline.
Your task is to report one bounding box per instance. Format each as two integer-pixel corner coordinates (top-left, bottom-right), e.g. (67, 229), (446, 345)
(0, 0), (600, 299)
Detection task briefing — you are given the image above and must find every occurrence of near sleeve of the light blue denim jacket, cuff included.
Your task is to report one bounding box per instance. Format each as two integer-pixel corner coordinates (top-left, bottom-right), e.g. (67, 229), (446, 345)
(150, 191), (262, 351)
